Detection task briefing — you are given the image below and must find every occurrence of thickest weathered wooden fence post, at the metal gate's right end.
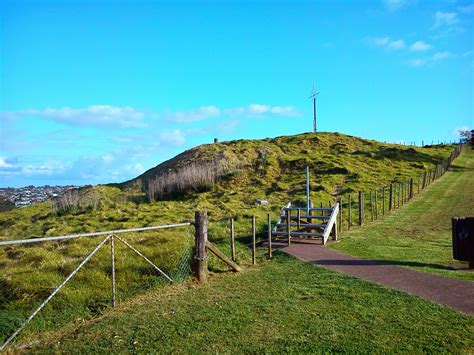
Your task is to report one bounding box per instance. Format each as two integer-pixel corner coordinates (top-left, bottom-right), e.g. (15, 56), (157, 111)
(194, 211), (208, 283)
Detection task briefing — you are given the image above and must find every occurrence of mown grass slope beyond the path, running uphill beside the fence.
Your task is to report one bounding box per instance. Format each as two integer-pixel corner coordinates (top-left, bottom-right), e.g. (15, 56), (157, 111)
(331, 148), (474, 281)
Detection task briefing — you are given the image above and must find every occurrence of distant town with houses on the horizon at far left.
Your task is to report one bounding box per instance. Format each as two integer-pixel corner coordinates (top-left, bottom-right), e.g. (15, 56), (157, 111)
(0, 185), (78, 207)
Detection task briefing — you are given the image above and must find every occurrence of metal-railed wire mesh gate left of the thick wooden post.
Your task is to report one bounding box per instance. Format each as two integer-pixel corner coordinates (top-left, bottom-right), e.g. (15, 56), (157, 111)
(0, 223), (194, 350)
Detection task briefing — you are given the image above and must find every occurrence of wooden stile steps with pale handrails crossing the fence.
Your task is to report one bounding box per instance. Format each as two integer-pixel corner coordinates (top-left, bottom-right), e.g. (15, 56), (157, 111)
(272, 202), (339, 245)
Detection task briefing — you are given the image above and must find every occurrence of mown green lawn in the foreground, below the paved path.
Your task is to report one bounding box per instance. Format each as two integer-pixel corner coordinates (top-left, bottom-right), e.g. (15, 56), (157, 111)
(18, 254), (474, 353)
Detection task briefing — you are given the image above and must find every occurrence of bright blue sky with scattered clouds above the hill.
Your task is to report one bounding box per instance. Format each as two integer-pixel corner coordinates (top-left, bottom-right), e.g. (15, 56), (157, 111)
(0, 0), (474, 187)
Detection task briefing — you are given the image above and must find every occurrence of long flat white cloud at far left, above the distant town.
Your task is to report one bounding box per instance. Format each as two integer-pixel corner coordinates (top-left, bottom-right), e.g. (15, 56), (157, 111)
(2, 105), (150, 128)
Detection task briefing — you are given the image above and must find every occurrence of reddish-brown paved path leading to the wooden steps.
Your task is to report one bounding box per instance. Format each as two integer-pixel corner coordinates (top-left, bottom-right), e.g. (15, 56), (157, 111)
(274, 240), (474, 316)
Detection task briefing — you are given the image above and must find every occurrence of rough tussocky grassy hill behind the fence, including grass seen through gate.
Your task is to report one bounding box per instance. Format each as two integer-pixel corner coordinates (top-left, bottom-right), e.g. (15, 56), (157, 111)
(0, 133), (460, 350)
